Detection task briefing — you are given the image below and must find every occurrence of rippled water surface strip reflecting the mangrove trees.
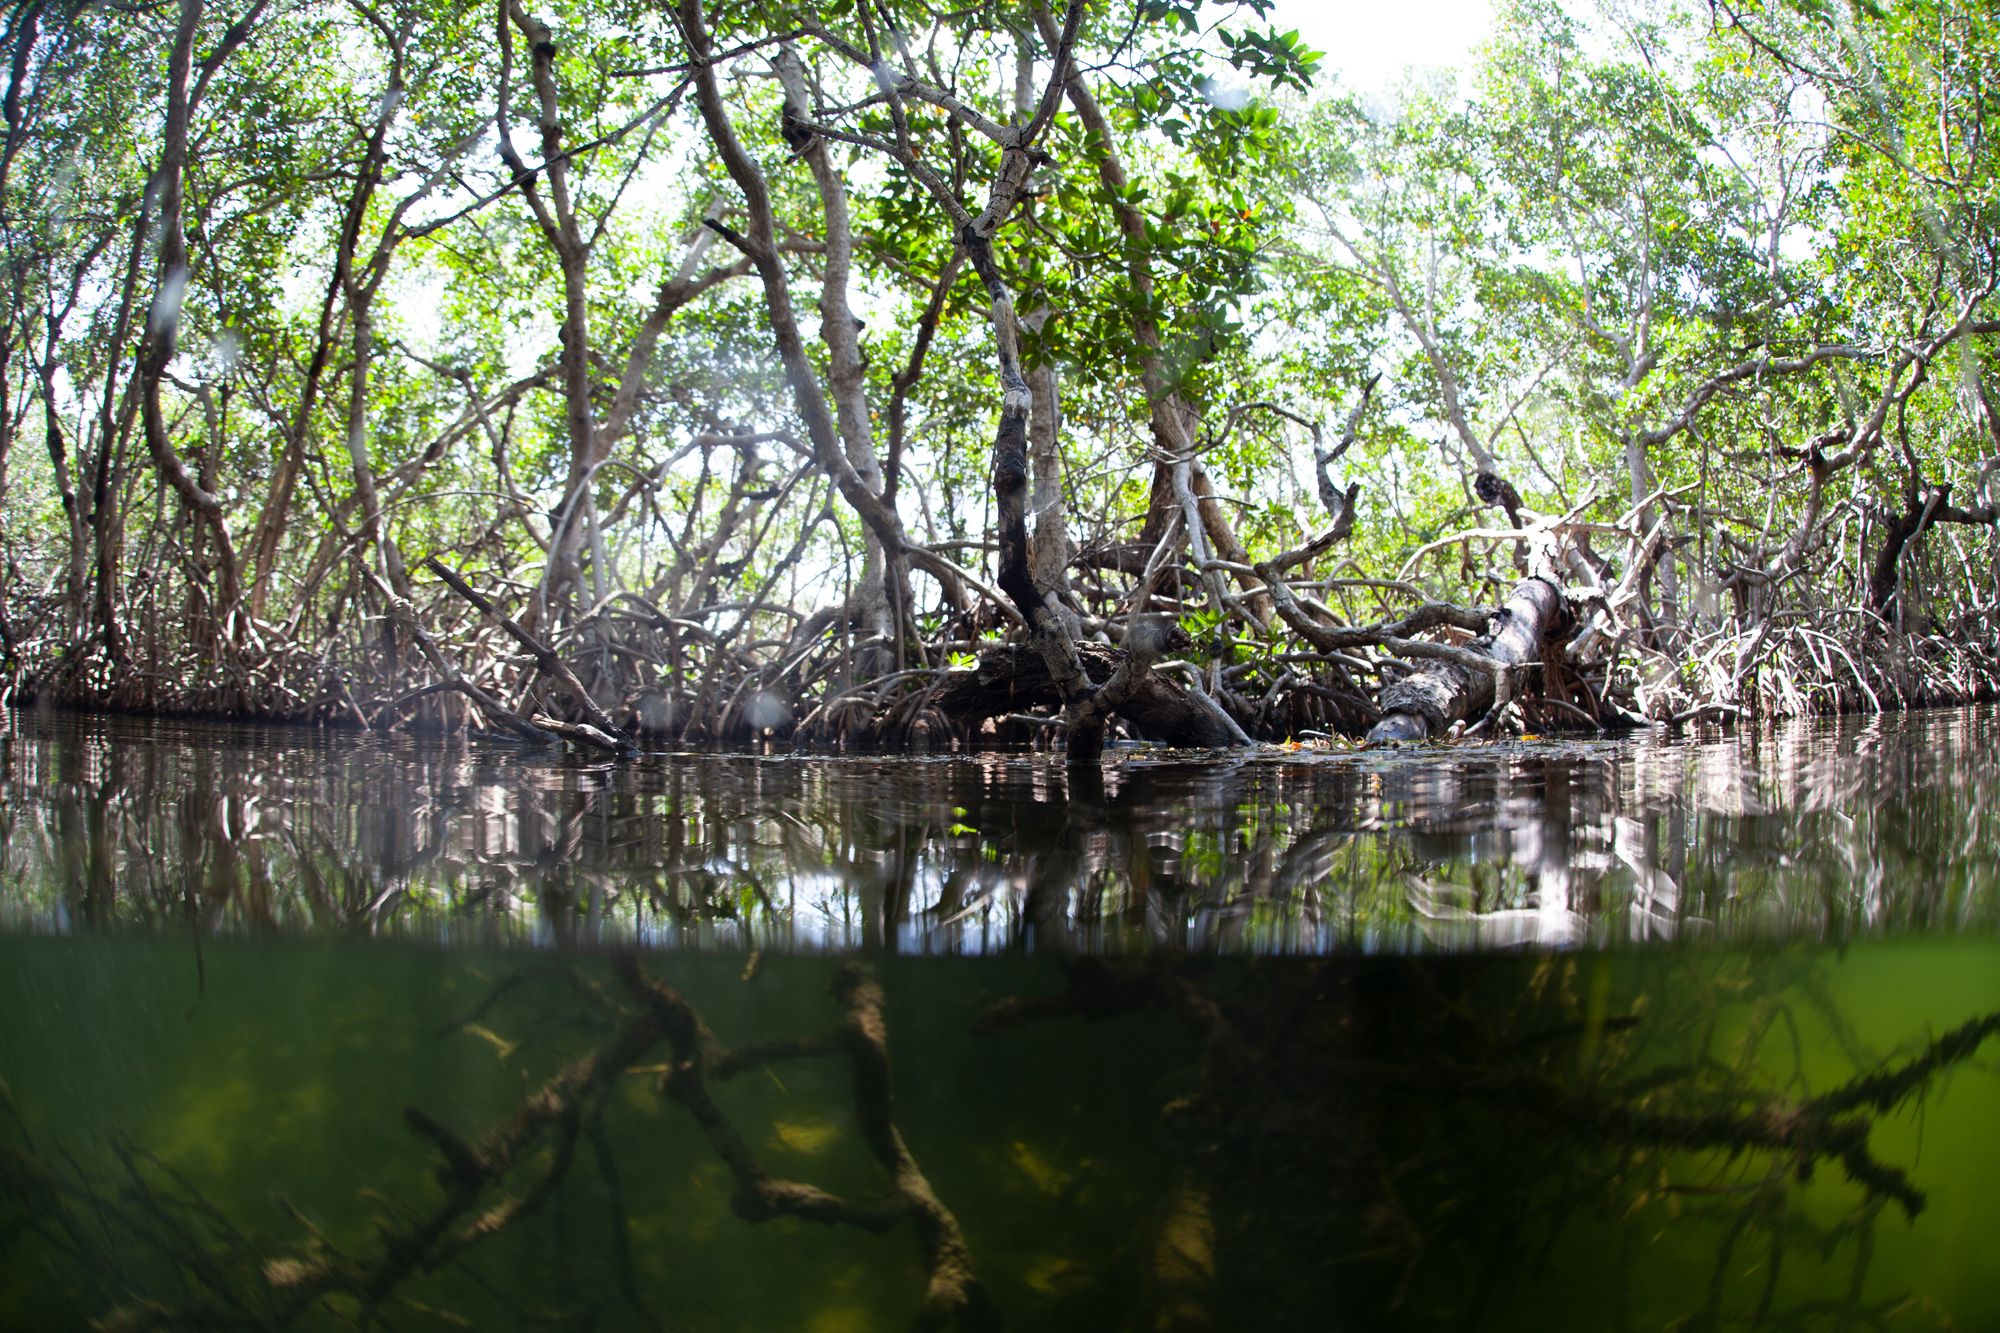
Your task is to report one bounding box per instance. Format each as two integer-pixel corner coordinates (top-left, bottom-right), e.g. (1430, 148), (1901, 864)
(0, 707), (2000, 953)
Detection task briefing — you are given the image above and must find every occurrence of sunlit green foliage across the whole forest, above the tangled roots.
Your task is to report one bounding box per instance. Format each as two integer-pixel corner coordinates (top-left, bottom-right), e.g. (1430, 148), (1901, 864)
(0, 0), (2000, 716)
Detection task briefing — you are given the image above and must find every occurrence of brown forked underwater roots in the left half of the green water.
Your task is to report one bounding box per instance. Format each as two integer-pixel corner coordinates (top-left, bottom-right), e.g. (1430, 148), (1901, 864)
(0, 955), (998, 1333)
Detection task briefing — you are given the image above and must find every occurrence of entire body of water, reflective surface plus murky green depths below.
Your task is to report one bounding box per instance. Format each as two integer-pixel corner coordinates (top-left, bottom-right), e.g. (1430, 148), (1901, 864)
(0, 711), (2000, 1333)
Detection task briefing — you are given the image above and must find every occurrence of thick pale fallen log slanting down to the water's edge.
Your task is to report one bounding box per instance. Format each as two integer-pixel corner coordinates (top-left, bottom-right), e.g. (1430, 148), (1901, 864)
(1368, 578), (1570, 745)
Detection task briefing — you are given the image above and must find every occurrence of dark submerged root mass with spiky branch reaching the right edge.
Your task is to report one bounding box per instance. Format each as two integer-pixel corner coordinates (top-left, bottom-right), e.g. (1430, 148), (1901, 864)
(980, 961), (2000, 1329)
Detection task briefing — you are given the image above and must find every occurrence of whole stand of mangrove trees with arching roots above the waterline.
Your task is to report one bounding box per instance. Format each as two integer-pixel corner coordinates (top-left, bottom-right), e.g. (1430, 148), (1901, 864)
(0, 0), (2000, 753)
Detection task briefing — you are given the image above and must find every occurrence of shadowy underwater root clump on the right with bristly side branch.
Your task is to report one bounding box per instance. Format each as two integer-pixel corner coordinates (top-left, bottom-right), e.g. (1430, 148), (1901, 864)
(978, 959), (2000, 1307)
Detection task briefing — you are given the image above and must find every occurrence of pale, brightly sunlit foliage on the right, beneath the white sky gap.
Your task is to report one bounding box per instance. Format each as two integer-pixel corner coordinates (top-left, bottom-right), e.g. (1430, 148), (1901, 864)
(1276, 0), (2000, 588)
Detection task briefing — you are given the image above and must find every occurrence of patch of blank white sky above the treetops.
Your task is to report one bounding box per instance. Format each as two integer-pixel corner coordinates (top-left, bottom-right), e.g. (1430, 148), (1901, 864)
(1272, 0), (1492, 94)
